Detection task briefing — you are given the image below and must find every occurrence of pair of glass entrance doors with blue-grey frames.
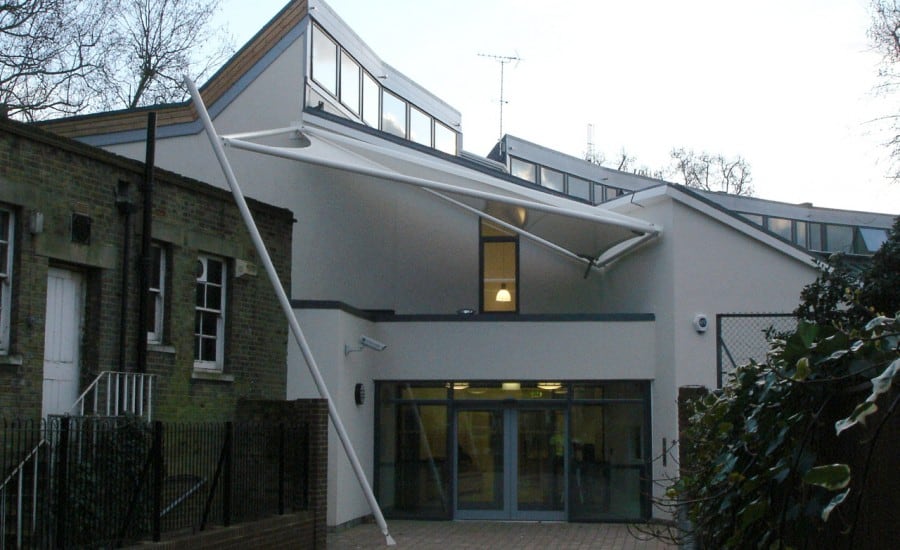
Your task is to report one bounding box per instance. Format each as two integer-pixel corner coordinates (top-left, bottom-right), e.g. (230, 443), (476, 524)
(454, 406), (566, 520)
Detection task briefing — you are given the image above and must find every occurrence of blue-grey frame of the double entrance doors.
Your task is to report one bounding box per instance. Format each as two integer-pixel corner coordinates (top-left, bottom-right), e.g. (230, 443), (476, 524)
(448, 400), (571, 521)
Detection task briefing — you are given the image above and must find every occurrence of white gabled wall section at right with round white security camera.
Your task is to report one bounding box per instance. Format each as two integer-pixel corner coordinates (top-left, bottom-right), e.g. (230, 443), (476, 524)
(601, 195), (817, 512)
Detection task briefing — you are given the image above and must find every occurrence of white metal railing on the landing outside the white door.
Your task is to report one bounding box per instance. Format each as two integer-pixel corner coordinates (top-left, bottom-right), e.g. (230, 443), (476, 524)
(69, 371), (156, 422)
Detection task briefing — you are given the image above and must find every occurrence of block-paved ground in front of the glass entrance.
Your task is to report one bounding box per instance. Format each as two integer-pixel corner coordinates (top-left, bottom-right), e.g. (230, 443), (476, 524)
(328, 520), (678, 550)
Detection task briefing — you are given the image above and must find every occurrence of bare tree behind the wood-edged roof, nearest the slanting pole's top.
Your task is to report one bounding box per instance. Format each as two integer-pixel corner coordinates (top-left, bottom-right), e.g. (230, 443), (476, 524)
(97, 0), (233, 109)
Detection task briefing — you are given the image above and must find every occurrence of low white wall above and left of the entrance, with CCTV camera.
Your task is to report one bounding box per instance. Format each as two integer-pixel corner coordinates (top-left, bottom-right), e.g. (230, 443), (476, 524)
(287, 310), (655, 526)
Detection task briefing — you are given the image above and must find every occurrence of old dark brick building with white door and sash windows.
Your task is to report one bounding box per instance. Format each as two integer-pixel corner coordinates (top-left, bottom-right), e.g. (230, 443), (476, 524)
(0, 119), (292, 420)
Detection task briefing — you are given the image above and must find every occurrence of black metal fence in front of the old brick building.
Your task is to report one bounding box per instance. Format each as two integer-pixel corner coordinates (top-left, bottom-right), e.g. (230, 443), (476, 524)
(0, 417), (310, 548)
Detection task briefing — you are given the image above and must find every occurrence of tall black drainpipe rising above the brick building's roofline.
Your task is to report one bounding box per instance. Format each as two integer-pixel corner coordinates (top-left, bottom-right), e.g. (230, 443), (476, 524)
(137, 111), (156, 378)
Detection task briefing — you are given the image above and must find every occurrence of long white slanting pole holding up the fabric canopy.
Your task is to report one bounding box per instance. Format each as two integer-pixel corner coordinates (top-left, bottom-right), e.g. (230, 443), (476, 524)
(184, 76), (397, 546)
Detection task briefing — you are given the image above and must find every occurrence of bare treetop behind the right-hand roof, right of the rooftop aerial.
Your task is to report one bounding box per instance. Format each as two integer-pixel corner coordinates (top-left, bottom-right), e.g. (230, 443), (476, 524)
(670, 147), (753, 196)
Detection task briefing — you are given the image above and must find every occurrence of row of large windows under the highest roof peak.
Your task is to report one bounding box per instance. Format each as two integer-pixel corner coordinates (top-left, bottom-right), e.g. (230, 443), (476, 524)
(311, 25), (457, 155)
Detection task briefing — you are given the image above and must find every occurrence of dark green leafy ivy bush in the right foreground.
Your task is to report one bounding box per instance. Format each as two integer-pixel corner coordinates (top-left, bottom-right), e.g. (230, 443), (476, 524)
(668, 221), (900, 548)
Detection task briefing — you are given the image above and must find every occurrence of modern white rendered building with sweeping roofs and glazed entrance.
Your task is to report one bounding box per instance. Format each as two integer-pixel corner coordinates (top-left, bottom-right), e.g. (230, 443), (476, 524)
(40, 0), (890, 525)
